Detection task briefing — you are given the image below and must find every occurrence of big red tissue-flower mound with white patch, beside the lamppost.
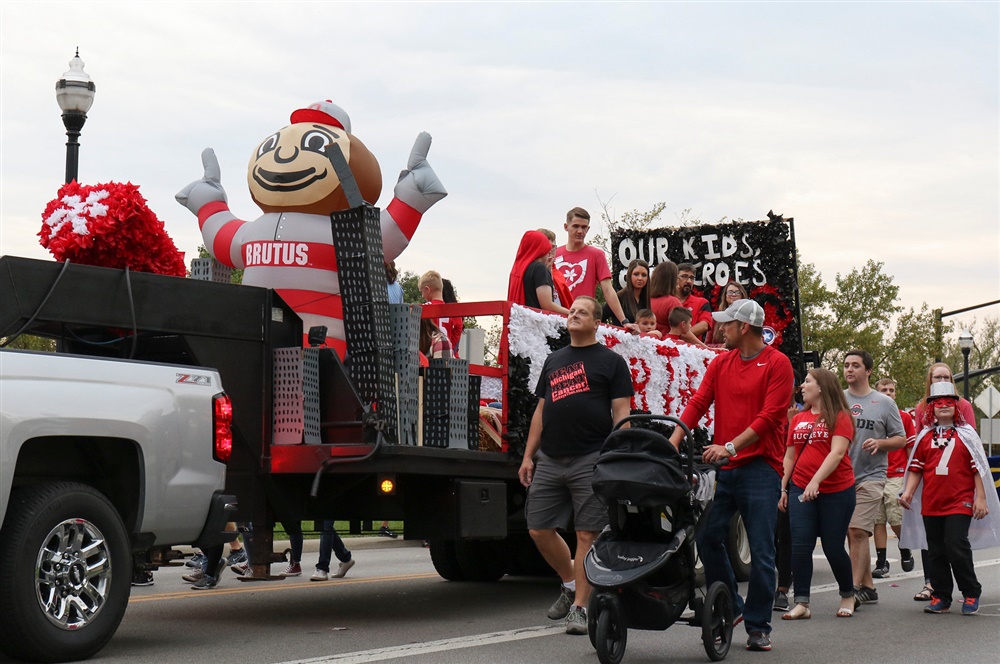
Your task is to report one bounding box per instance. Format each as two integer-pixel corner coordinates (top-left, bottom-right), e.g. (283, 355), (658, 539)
(38, 182), (186, 277)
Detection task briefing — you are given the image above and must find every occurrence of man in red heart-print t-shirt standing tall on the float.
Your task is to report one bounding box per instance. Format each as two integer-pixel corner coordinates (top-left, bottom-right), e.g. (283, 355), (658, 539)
(555, 207), (637, 331)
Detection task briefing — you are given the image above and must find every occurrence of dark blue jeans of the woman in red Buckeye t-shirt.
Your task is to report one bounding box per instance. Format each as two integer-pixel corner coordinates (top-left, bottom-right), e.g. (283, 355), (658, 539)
(788, 484), (857, 602)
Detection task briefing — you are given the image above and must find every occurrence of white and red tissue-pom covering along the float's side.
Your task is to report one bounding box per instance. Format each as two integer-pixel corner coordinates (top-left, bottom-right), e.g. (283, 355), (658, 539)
(508, 305), (720, 432)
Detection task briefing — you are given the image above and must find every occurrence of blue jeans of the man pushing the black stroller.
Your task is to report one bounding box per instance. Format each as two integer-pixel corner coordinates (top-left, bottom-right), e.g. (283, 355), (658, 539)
(698, 459), (781, 634)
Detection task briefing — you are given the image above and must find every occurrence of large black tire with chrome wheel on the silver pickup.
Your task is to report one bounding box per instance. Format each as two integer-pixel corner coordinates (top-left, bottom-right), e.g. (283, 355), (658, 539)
(0, 482), (132, 662)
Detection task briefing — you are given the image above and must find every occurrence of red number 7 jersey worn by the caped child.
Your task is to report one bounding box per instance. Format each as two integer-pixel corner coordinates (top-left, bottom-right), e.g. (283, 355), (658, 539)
(910, 427), (979, 516)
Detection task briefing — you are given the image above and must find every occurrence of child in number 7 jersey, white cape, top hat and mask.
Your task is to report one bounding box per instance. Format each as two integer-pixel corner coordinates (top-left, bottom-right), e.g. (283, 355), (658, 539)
(899, 383), (1000, 615)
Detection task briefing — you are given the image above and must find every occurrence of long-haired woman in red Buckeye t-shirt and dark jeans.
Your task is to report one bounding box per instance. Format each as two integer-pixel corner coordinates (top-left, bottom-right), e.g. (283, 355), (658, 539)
(778, 369), (856, 620)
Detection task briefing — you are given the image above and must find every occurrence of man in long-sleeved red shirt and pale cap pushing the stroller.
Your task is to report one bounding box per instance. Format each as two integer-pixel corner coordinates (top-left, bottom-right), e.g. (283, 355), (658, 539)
(670, 300), (794, 650)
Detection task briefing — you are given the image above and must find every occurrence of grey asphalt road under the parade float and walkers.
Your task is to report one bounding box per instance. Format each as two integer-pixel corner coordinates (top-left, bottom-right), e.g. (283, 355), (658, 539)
(4, 541), (1000, 664)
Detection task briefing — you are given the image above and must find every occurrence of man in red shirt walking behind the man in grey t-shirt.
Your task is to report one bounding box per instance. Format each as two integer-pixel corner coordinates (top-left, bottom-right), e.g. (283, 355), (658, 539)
(872, 378), (917, 579)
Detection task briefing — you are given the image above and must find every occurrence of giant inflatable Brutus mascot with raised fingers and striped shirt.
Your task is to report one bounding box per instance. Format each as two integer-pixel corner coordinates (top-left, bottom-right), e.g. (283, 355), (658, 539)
(176, 101), (448, 356)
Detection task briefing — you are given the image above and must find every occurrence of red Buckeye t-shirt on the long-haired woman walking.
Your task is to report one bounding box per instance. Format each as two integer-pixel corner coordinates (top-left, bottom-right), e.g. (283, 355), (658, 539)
(788, 410), (854, 493)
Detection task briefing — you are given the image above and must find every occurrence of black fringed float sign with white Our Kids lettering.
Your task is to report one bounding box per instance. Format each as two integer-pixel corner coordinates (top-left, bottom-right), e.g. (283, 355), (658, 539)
(611, 213), (802, 371)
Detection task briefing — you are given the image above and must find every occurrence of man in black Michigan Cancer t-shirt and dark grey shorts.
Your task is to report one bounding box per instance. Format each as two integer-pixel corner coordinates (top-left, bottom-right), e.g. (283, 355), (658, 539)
(518, 297), (633, 634)
